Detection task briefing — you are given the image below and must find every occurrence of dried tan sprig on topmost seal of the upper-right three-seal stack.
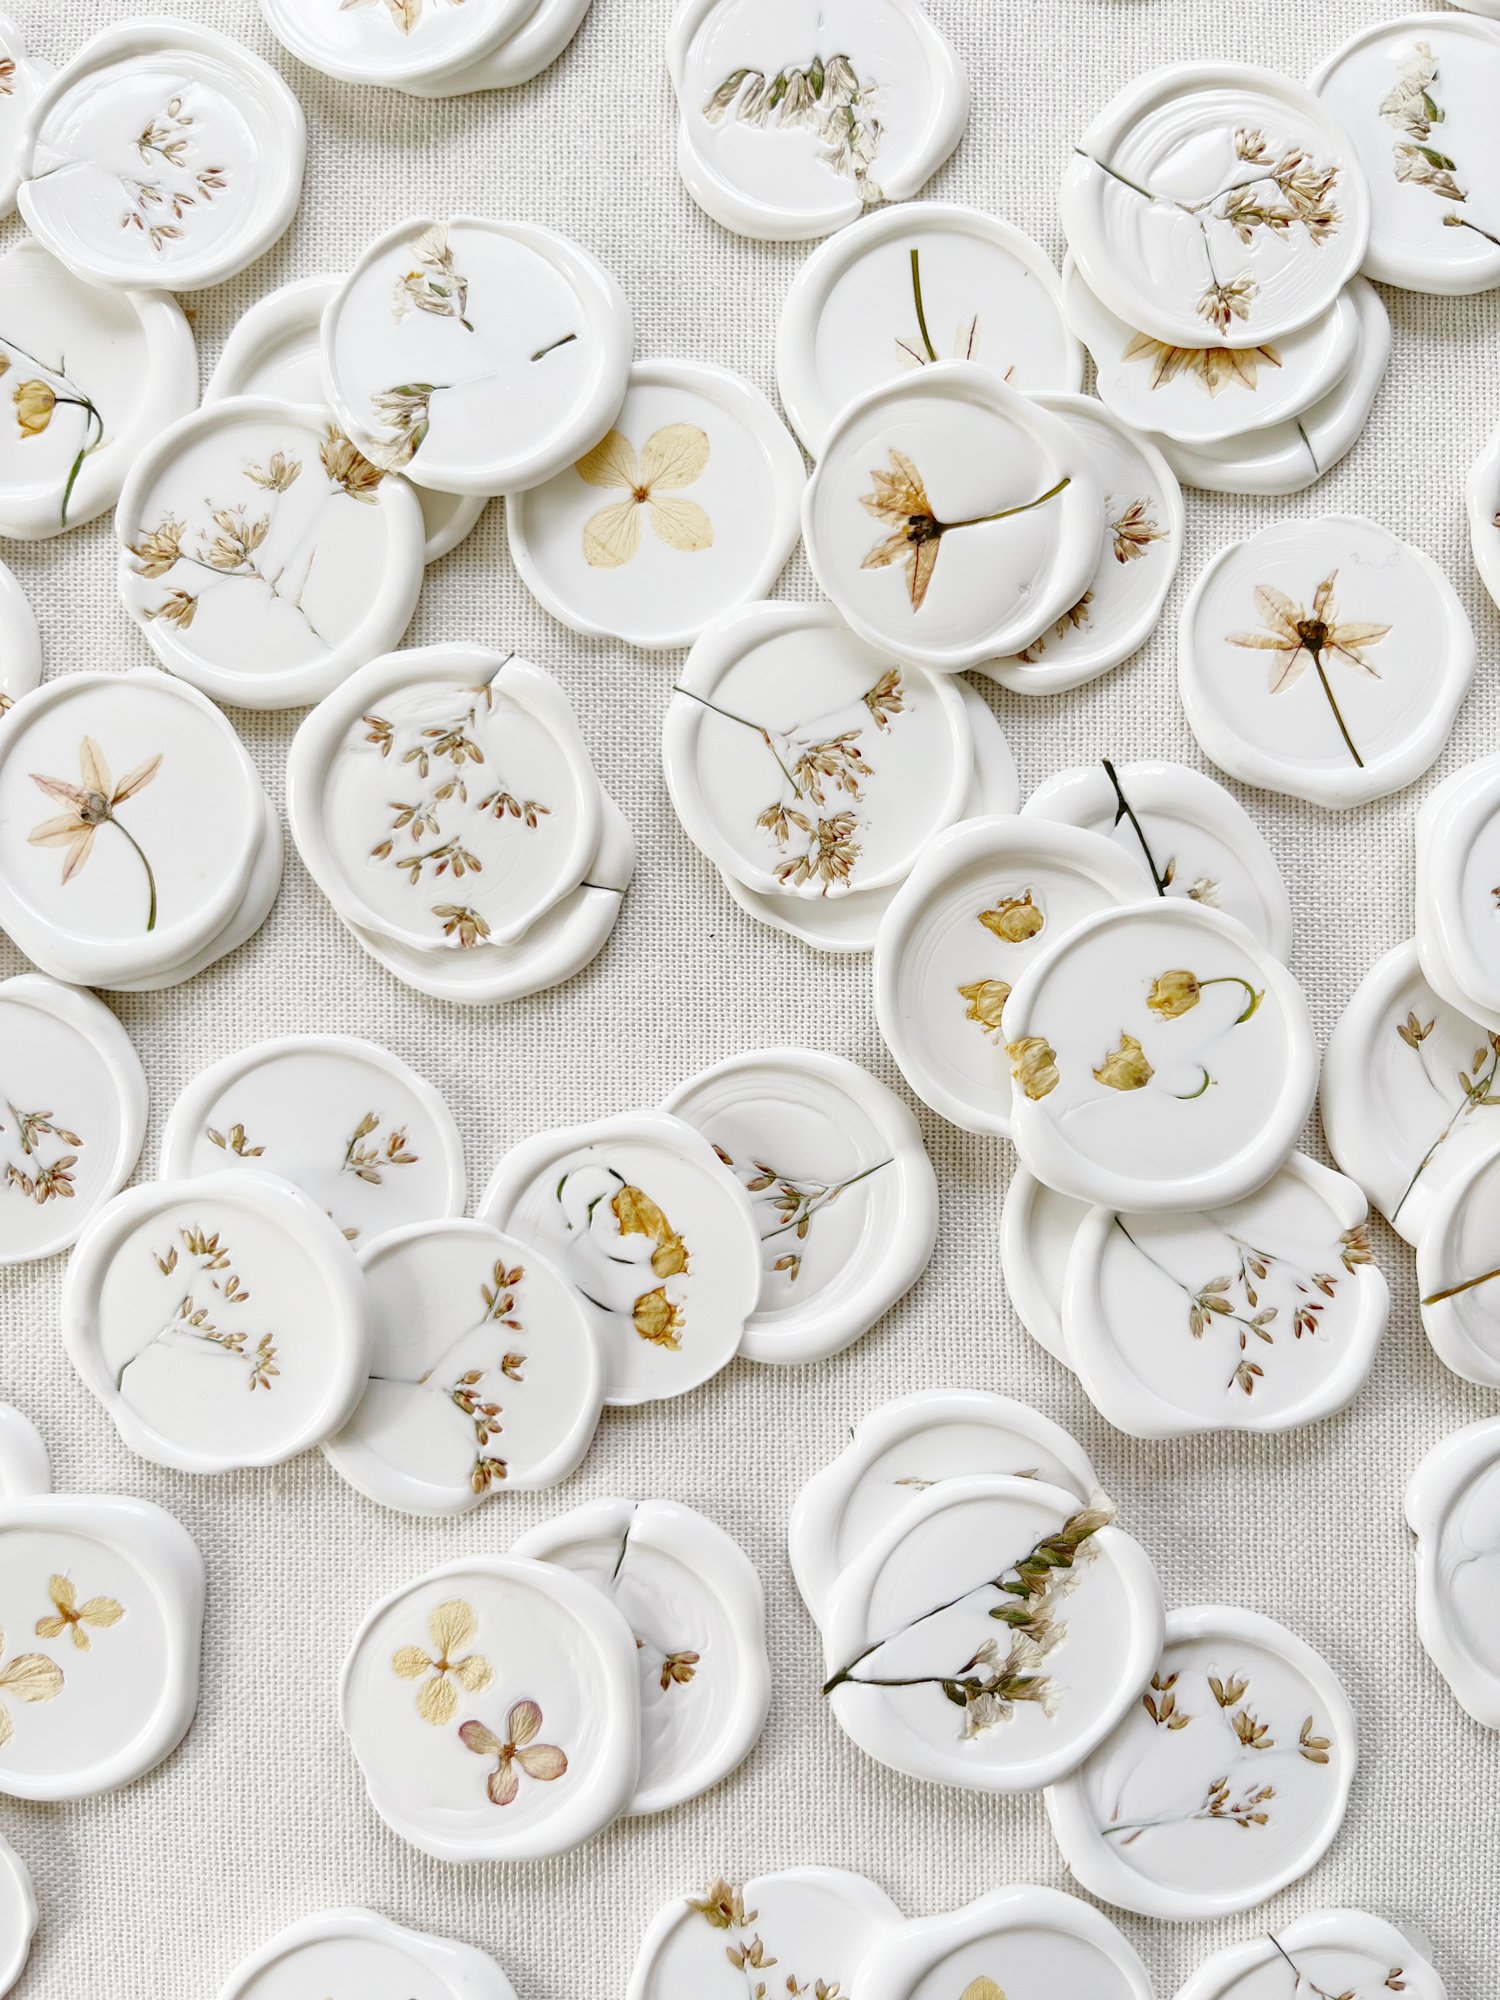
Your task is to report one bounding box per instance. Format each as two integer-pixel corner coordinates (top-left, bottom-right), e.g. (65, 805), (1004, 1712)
(1080, 126), (1342, 334)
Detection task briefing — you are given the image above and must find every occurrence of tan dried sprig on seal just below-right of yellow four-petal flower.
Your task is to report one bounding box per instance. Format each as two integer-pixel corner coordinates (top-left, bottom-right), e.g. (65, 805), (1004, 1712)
(672, 666), (906, 896)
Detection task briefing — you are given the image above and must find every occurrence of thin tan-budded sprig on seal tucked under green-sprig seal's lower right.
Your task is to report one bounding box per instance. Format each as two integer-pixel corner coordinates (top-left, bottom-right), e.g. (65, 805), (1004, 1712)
(1102, 1670), (1332, 1848)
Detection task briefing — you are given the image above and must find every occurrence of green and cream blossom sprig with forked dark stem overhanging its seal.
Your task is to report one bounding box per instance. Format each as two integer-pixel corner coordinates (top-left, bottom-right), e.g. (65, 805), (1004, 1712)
(822, 1506), (1114, 1738)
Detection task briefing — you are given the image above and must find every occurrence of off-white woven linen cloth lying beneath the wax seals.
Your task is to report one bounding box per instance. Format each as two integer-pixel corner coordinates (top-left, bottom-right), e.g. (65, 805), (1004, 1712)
(0, 0), (1500, 2000)
